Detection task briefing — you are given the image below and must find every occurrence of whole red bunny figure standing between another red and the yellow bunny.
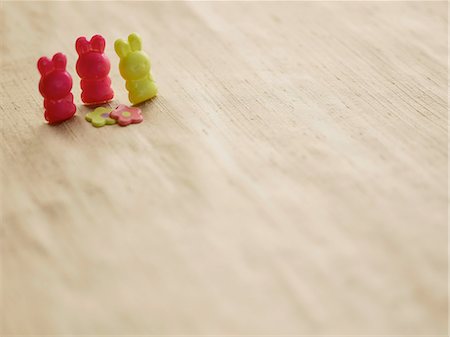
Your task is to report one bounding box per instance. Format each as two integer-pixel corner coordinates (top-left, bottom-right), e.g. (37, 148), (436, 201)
(75, 35), (114, 104)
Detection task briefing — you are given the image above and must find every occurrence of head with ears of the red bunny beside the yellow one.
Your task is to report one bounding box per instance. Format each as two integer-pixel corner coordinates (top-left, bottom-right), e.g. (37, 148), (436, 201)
(75, 35), (111, 80)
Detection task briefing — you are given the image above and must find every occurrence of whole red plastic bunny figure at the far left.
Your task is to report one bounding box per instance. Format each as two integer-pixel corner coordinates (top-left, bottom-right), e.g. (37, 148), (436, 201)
(37, 53), (76, 124)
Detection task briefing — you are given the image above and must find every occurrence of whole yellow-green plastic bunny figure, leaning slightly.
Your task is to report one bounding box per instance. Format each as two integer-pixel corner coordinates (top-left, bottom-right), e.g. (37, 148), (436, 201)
(114, 33), (158, 104)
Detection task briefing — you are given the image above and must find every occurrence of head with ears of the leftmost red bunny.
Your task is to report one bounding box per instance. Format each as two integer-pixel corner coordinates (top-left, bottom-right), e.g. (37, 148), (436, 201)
(37, 53), (72, 100)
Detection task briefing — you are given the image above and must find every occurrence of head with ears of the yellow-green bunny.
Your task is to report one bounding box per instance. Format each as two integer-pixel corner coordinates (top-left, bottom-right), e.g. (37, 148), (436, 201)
(114, 33), (150, 80)
